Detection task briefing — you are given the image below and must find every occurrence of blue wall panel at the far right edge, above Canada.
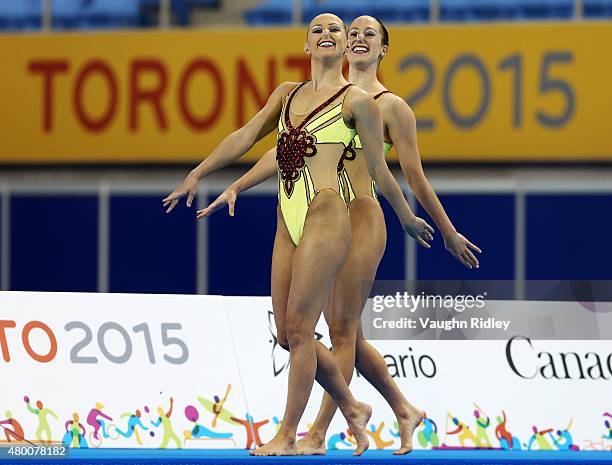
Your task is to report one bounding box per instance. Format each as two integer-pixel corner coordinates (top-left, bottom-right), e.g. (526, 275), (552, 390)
(526, 194), (612, 279)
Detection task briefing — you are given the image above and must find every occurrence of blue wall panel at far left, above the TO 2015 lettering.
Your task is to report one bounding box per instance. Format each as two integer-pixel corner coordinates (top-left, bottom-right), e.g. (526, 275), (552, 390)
(10, 194), (98, 292)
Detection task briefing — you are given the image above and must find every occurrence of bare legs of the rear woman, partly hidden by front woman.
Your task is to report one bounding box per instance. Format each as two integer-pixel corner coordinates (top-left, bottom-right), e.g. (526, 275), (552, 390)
(299, 196), (424, 454)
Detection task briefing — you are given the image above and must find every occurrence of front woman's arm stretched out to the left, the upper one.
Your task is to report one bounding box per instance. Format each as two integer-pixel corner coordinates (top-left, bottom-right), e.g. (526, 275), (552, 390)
(162, 82), (295, 213)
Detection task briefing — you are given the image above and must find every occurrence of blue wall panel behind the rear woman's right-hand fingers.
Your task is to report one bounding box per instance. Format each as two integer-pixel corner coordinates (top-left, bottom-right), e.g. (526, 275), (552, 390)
(417, 194), (515, 279)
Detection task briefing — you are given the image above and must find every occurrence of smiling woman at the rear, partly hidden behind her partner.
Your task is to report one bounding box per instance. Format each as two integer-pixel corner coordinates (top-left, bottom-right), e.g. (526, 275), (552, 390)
(201, 16), (480, 454)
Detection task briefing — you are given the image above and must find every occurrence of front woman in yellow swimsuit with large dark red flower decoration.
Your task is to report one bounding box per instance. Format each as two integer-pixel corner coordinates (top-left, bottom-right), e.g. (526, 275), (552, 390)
(163, 14), (432, 455)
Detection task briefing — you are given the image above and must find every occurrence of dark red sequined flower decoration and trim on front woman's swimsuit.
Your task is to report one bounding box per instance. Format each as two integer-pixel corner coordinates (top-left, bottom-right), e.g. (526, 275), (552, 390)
(276, 82), (352, 197)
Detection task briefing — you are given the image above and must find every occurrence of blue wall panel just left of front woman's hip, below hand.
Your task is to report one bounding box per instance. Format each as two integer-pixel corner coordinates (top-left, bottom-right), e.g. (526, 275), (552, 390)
(208, 194), (278, 295)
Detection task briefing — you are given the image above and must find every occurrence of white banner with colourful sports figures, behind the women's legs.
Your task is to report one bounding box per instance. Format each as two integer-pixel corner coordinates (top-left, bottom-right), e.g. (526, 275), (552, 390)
(0, 292), (612, 450)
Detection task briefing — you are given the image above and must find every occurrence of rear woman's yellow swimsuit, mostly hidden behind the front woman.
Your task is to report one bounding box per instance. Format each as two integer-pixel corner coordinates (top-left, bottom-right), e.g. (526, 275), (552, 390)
(338, 90), (393, 205)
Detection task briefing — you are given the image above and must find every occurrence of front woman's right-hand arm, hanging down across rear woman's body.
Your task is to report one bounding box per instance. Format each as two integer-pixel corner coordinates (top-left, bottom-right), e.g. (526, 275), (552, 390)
(346, 89), (433, 248)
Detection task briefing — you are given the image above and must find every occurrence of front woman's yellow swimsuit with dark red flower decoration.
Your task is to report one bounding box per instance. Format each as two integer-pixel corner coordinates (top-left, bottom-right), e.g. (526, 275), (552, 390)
(276, 82), (356, 245)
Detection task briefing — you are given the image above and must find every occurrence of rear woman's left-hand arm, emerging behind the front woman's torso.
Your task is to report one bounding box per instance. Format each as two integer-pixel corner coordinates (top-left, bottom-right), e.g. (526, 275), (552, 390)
(198, 147), (277, 218)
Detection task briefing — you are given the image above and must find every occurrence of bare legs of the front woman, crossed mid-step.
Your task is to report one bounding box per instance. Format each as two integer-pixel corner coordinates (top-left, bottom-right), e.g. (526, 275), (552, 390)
(254, 190), (371, 455)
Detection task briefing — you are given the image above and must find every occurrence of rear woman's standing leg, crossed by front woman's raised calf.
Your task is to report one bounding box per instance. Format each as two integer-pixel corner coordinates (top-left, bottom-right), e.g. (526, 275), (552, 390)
(298, 196), (387, 455)
